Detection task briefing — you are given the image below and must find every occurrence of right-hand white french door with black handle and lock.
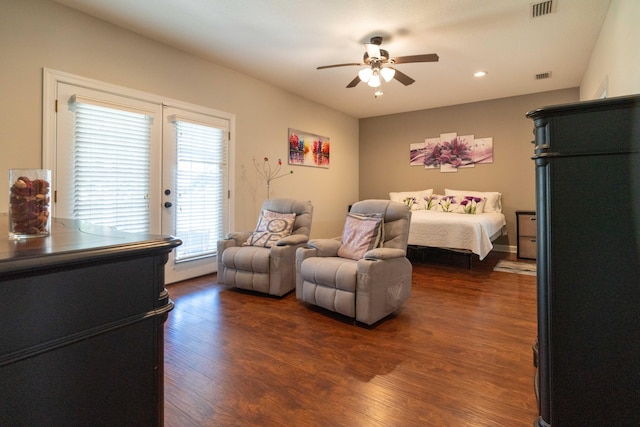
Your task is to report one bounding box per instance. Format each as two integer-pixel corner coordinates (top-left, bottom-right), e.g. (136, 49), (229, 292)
(162, 107), (229, 283)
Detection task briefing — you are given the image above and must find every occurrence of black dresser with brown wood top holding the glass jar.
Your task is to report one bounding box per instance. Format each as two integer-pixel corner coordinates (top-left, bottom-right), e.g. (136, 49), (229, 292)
(0, 214), (181, 426)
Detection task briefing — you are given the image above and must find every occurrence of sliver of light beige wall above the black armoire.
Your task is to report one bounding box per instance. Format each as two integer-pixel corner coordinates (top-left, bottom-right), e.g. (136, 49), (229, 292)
(580, 0), (640, 100)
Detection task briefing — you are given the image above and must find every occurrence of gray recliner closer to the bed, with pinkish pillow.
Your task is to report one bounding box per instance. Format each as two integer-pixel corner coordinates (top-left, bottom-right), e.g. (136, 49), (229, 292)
(296, 200), (412, 325)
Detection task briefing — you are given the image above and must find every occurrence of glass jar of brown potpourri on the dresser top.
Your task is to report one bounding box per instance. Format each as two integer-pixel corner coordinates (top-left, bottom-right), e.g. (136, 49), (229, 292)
(9, 169), (51, 240)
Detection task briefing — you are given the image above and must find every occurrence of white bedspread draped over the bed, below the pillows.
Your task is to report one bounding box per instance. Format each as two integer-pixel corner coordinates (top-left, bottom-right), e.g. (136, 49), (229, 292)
(409, 210), (507, 260)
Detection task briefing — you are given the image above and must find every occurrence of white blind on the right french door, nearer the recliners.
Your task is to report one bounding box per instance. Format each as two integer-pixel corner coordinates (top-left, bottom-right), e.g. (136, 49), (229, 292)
(171, 116), (227, 263)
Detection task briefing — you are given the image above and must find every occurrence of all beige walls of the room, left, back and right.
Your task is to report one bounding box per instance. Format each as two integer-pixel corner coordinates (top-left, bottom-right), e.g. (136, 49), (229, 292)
(0, 0), (640, 245)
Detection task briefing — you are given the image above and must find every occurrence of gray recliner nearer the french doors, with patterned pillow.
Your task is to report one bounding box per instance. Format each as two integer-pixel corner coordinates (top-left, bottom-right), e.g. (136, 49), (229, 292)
(218, 199), (313, 296)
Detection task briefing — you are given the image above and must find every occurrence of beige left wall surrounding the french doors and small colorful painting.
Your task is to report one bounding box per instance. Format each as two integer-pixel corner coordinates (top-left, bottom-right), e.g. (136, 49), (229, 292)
(0, 0), (358, 236)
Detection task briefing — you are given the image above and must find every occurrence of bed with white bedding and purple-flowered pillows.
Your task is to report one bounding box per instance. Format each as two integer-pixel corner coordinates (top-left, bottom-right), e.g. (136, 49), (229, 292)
(389, 189), (507, 262)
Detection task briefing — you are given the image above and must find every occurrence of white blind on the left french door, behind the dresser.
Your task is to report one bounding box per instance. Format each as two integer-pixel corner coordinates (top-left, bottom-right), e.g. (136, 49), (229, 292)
(71, 97), (153, 232)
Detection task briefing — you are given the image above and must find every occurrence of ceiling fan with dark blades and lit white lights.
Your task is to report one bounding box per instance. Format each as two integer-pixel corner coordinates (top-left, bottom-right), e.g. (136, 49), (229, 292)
(316, 36), (439, 95)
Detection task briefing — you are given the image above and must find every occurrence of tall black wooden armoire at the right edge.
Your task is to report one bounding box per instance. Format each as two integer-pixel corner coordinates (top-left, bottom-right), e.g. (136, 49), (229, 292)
(527, 96), (640, 427)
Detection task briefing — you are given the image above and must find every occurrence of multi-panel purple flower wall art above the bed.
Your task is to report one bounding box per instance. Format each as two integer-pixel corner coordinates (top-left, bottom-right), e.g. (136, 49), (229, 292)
(409, 133), (493, 172)
